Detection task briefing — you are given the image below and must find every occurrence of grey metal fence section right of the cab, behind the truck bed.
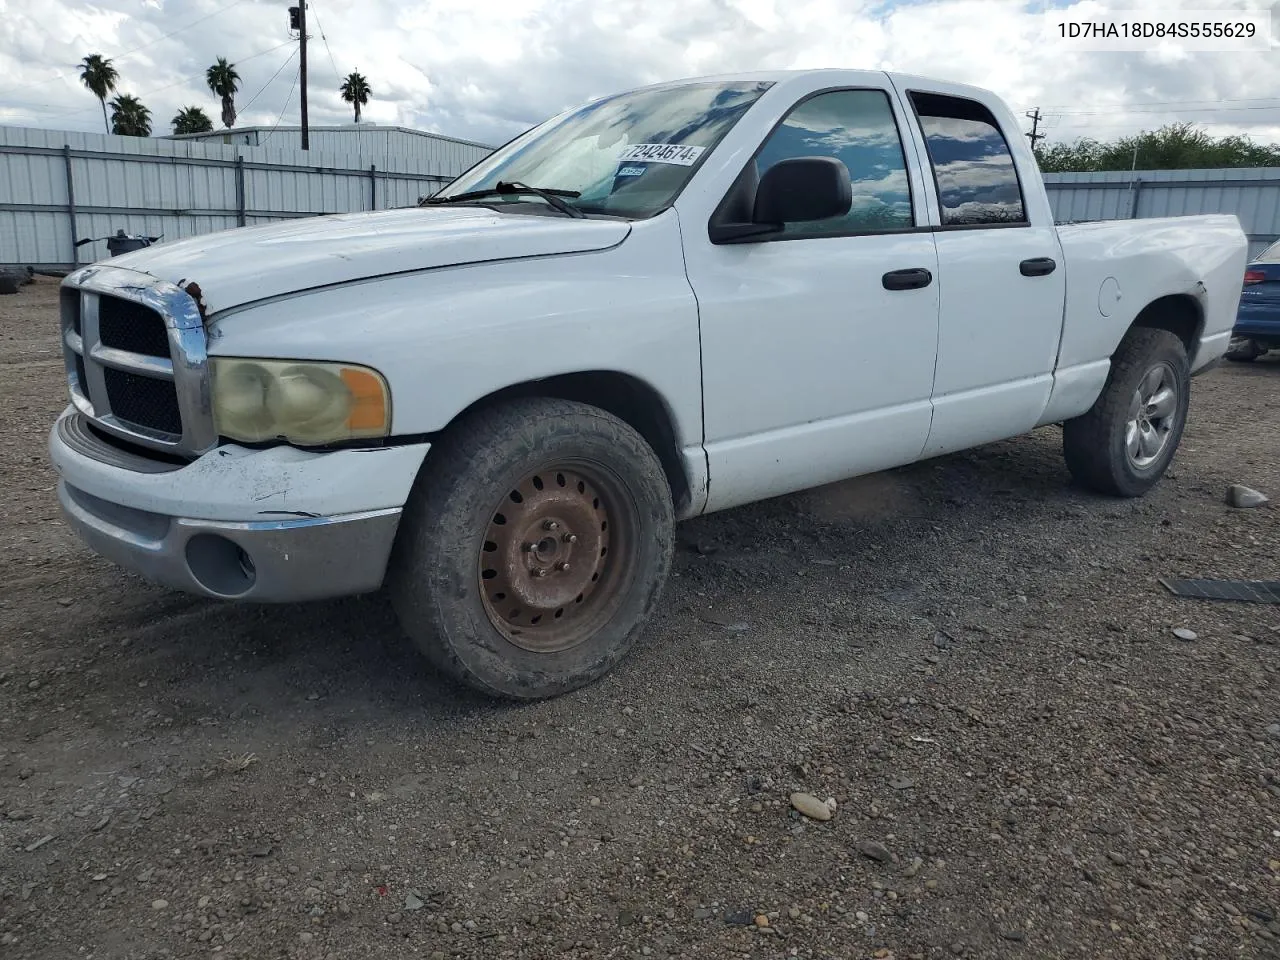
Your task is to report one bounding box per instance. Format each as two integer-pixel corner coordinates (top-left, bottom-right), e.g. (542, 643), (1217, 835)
(1044, 168), (1280, 257)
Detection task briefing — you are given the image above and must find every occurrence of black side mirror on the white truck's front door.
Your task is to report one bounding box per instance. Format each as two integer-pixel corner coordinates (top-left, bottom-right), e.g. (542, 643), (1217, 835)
(709, 156), (854, 243)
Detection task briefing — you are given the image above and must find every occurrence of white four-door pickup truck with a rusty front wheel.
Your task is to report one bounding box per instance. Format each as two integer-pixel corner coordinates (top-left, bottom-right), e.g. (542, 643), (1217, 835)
(50, 70), (1245, 698)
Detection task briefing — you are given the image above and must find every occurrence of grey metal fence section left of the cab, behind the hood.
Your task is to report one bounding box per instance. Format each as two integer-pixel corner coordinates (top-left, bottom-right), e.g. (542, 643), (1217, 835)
(0, 127), (488, 270)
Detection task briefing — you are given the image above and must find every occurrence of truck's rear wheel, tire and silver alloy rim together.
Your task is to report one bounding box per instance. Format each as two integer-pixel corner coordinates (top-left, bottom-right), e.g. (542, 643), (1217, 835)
(1062, 326), (1190, 497)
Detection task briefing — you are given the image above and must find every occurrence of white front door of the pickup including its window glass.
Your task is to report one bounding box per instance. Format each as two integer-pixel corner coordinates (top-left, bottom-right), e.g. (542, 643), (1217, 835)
(682, 88), (940, 511)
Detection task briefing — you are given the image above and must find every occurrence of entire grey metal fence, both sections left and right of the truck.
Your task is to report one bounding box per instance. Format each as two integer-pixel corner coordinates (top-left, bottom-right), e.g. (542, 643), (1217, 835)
(10, 127), (1280, 269)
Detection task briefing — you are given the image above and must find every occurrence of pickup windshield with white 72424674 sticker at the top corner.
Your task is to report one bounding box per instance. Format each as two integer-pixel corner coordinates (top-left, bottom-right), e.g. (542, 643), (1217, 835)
(431, 81), (772, 218)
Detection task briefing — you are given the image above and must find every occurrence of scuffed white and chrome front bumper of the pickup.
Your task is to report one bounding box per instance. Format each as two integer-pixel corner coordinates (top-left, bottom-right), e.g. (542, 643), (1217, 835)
(49, 408), (429, 603)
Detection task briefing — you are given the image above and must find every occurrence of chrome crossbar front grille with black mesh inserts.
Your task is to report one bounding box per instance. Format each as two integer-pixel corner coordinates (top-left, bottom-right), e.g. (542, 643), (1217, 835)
(61, 265), (218, 458)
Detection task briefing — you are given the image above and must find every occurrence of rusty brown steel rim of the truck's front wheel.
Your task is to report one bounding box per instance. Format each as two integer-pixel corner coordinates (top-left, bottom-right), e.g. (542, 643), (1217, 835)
(476, 461), (637, 654)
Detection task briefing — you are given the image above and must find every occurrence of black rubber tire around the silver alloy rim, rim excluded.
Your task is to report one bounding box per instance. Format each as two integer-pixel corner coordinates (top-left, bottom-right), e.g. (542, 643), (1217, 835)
(1062, 326), (1190, 497)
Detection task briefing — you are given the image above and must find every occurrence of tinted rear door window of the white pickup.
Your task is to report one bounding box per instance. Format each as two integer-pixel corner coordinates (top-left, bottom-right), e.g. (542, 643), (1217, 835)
(911, 93), (1027, 227)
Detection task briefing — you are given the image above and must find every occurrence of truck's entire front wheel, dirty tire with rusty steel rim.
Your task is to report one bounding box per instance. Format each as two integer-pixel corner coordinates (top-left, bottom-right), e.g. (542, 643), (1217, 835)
(388, 399), (675, 700)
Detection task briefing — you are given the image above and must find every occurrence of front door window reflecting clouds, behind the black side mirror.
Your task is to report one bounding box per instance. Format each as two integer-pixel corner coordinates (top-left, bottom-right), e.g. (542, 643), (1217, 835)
(755, 90), (915, 236)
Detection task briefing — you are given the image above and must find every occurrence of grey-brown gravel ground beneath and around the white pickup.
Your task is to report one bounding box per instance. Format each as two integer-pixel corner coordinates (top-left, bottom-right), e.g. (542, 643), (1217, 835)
(0, 272), (1280, 960)
